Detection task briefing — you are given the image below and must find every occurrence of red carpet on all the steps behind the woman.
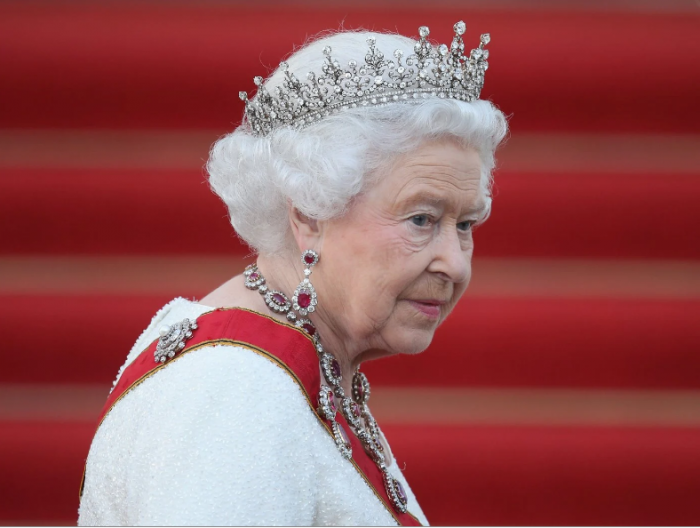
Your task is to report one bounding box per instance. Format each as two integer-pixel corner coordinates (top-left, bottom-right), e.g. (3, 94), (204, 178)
(0, 1), (700, 525)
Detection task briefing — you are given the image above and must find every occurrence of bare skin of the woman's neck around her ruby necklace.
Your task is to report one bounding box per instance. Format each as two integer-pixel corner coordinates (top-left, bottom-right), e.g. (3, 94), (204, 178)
(258, 255), (365, 395)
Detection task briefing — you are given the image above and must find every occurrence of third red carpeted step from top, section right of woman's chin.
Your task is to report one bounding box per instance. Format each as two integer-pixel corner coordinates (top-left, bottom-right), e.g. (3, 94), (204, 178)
(364, 298), (700, 388)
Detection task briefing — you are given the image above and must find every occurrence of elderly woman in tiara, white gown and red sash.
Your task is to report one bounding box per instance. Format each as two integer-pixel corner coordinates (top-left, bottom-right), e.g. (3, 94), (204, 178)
(79, 22), (506, 525)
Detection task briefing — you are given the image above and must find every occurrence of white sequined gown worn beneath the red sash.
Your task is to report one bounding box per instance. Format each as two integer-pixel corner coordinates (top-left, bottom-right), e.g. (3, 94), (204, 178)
(78, 298), (427, 526)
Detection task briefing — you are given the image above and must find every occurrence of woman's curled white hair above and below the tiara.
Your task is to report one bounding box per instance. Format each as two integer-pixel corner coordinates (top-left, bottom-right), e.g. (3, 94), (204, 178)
(207, 32), (507, 255)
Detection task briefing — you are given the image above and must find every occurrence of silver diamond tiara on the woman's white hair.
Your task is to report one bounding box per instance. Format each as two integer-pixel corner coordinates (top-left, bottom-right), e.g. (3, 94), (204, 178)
(239, 21), (491, 136)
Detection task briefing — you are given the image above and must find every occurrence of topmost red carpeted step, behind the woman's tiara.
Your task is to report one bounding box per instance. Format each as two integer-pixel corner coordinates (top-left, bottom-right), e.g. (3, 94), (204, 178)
(0, 1), (700, 132)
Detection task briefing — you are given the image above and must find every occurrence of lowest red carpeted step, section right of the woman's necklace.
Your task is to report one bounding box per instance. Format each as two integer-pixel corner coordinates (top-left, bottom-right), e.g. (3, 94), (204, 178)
(383, 426), (700, 526)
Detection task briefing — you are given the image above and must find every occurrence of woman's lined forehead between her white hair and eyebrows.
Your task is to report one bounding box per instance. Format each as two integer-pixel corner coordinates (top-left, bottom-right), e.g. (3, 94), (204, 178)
(376, 139), (484, 210)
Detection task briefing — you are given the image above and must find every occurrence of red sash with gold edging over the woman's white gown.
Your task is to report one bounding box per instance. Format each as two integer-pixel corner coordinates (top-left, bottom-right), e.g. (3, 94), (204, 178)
(80, 308), (420, 526)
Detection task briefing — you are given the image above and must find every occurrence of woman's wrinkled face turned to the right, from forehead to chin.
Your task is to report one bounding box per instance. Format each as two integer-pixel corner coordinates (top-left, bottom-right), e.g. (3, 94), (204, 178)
(312, 139), (485, 356)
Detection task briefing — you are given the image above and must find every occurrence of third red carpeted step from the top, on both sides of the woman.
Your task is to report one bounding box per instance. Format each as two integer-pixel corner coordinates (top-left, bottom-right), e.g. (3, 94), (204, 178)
(0, 296), (700, 389)
